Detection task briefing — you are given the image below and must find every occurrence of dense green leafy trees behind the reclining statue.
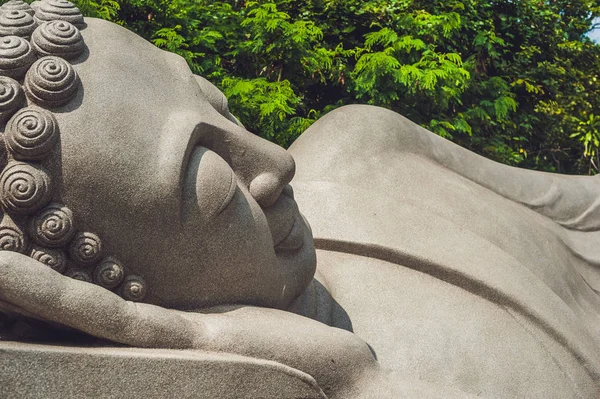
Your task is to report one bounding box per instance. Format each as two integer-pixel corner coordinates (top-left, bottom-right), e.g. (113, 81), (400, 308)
(52, 0), (600, 174)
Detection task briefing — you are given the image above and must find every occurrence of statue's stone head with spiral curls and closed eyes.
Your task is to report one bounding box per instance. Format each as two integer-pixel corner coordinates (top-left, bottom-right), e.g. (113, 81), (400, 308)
(0, 0), (315, 308)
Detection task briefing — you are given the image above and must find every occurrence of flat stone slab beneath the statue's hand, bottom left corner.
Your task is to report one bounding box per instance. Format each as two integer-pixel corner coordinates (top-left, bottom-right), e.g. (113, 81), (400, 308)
(0, 342), (326, 399)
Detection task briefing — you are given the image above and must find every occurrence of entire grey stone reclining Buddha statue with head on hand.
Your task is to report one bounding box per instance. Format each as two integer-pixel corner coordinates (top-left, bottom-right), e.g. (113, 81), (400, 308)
(0, 0), (600, 398)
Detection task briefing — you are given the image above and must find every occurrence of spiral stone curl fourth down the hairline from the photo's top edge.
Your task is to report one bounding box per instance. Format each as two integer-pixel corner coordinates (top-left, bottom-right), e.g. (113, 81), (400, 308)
(5, 108), (59, 160)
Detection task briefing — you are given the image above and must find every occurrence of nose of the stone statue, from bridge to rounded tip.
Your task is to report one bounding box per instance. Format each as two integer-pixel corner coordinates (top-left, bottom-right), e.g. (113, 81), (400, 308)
(202, 111), (296, 208)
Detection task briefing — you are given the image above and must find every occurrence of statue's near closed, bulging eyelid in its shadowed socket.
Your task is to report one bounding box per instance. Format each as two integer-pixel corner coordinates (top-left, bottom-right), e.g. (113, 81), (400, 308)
(183, 147), (236, 224)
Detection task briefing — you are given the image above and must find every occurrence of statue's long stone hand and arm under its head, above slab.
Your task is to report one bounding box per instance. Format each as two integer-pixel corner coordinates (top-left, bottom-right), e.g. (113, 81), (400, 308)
(0, 251), (378, 396)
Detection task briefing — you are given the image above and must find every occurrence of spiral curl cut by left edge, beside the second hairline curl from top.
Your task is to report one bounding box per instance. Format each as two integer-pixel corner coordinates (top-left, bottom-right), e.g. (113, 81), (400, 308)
(0, 35), (36, 80)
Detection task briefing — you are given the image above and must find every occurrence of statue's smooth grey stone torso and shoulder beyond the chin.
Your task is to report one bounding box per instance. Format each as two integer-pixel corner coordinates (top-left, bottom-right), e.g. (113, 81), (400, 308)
(290, 106), (600, 398)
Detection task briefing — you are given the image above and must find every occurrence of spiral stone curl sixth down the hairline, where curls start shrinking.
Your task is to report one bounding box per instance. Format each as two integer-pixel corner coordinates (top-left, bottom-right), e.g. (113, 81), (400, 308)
(28, 203), (75, 248)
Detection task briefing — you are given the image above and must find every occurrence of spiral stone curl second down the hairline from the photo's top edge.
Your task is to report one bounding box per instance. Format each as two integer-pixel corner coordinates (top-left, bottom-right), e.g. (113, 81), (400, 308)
(31, 21), (84, 60)
